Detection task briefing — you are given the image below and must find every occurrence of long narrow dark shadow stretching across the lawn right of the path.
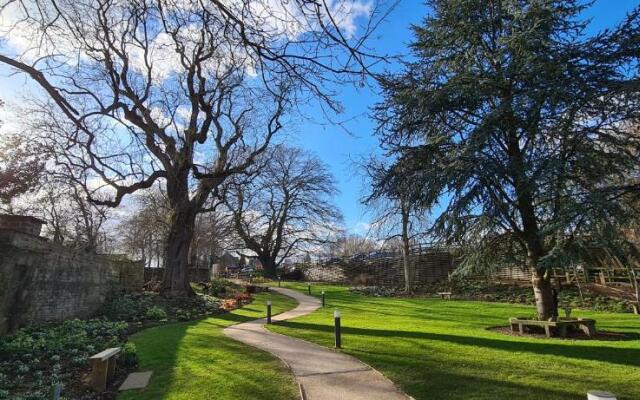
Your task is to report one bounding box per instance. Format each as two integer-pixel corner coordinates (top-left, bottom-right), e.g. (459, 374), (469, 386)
(278, 321), (640, 367)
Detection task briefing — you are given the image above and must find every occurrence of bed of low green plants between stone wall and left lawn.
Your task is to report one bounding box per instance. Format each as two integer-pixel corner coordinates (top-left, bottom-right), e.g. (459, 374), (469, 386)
(0, 280), (260, 400)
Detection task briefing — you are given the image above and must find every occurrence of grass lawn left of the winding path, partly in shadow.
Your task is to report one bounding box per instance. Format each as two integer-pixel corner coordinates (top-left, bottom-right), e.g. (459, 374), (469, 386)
(118, 293), (298, 400)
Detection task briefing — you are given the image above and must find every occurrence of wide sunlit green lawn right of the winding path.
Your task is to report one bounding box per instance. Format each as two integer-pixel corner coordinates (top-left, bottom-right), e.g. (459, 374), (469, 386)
(270, 284), (640, 400)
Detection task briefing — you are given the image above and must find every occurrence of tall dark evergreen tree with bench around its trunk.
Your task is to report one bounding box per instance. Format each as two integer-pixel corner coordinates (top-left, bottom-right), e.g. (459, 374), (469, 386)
(374, 0), (640, 320)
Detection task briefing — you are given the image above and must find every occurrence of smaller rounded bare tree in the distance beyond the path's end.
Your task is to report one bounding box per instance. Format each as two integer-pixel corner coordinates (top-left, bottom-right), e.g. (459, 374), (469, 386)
(225, 145), (342, 277)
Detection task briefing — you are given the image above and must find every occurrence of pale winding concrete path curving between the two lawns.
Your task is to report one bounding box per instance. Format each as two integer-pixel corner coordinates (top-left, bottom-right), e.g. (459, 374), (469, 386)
(224, 288), (410, 400)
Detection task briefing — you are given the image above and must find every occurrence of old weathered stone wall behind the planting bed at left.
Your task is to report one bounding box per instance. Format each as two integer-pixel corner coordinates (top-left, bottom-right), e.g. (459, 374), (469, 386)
(0, 230), (144, 333)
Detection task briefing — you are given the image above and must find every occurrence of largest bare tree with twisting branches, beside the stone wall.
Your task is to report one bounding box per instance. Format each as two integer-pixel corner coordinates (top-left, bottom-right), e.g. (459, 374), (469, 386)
(0, 0), (383, 295)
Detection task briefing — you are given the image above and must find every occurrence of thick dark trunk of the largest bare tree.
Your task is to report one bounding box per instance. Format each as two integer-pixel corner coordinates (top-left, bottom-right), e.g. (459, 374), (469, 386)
(161, 202), (196, 296)
